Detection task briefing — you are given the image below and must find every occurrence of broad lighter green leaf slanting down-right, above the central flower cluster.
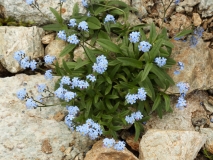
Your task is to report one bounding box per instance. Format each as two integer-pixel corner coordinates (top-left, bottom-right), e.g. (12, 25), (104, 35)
(97, 39), (121, 53)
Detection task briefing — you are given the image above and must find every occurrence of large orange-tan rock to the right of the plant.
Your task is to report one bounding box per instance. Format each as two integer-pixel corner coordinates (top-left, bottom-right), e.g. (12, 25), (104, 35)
(168, 39), (213, 93)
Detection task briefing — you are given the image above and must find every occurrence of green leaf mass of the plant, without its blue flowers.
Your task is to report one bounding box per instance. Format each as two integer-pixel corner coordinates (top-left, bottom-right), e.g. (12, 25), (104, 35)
(43, 0), (176, 139)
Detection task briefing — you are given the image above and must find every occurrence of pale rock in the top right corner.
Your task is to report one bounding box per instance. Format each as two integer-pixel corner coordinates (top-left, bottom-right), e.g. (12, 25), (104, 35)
(199, 0), (213, 17)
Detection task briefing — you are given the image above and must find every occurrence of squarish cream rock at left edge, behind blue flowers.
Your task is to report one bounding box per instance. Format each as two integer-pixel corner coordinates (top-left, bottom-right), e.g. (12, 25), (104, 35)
(0, 26), (44, 73)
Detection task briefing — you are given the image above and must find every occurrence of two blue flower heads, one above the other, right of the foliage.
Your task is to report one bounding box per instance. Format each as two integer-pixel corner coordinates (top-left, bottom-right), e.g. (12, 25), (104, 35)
(176, 82), (189, 109)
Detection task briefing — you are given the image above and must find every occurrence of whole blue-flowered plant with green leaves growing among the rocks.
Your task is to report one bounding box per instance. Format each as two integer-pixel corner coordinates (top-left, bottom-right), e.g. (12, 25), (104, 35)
(15, 0), (195, 150)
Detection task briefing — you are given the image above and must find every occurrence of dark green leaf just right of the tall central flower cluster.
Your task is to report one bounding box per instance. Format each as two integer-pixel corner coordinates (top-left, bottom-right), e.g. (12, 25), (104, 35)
(117, 57), (142, 69)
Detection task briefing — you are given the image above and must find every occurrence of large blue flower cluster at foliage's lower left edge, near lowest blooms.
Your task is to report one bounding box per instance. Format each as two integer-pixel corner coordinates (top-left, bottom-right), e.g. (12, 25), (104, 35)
(76, 119), (103, 140)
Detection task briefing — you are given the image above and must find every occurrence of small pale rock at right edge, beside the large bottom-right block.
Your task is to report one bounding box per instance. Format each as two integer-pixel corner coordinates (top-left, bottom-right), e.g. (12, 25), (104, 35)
(200, 128), (213, 154)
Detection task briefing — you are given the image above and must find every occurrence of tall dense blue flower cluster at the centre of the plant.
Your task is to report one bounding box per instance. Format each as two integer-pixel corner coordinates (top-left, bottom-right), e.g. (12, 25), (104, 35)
(92, 55), (108, 74)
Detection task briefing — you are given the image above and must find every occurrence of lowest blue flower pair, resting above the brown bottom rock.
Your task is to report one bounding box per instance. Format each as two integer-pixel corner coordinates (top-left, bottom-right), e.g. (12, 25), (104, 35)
(103, 138), (125, 151)
